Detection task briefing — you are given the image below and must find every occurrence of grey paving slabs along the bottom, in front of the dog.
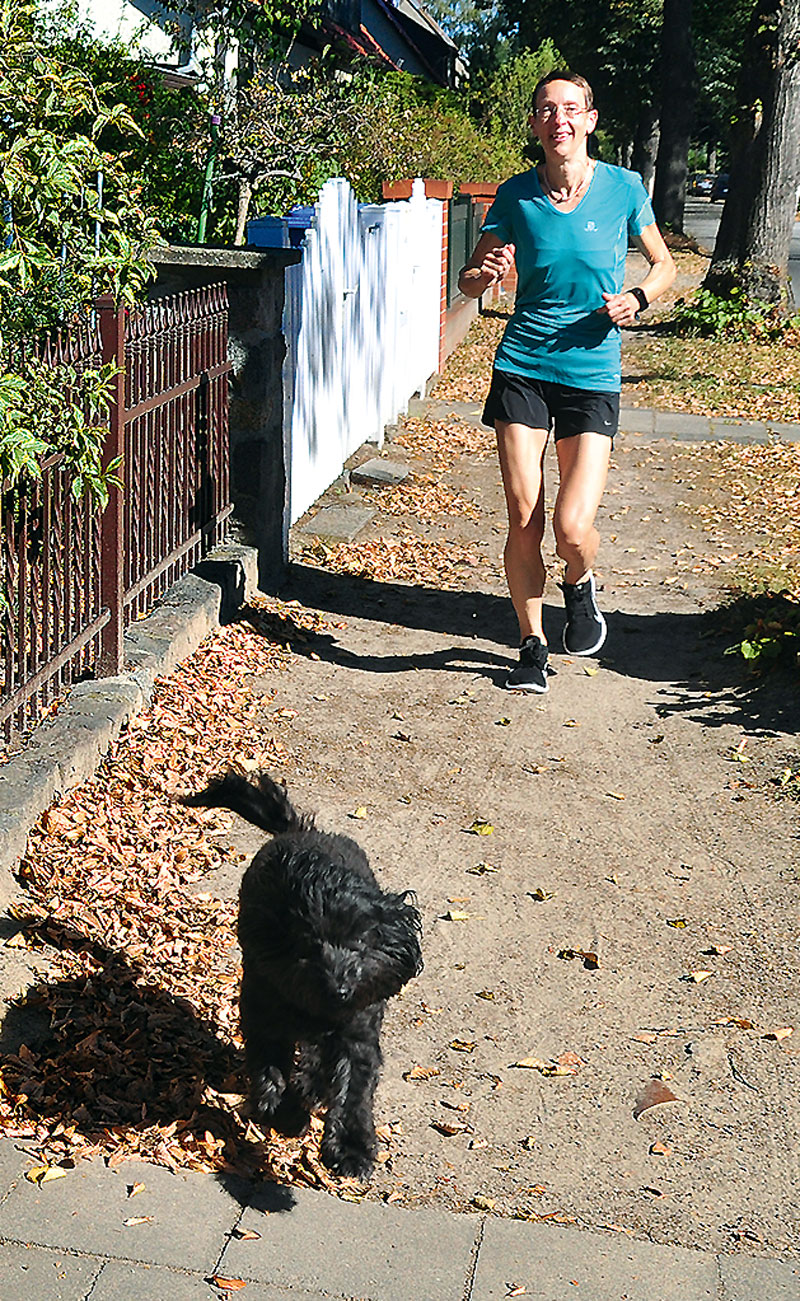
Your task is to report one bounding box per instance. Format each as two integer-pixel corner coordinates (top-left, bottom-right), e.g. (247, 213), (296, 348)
(0, 1142), (800, 1301)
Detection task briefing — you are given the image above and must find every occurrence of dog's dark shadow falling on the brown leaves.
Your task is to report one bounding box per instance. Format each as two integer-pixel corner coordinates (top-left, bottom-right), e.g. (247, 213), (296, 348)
(0, 919), (294, 1210)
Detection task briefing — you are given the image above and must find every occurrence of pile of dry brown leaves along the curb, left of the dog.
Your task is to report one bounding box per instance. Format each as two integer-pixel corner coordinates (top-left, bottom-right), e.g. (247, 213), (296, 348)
(0, 598), (348, 1184)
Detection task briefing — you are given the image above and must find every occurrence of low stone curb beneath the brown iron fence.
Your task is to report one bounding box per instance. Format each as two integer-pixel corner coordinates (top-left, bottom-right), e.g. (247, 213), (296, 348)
(0, 544), (258, 904)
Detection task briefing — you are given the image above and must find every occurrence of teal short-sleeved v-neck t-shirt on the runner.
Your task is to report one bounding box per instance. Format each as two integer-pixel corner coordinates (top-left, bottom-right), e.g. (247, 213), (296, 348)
(483, 163), (656, 393)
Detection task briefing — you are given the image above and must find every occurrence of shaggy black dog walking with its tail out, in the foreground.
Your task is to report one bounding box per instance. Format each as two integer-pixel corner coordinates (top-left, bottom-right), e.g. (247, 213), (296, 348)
(183, 773), (423, 1179)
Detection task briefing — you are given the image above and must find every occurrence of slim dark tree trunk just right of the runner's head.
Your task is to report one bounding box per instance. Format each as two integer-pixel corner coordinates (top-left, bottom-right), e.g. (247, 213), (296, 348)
(653, 0), (695, 233)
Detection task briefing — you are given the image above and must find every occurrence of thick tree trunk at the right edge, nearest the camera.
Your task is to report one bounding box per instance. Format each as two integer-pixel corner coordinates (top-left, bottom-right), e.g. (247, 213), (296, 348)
(704, 0), (800, 311)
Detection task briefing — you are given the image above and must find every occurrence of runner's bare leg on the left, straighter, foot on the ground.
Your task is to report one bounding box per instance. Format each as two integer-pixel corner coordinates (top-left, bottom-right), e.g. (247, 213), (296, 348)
(496, 420), (548, 641)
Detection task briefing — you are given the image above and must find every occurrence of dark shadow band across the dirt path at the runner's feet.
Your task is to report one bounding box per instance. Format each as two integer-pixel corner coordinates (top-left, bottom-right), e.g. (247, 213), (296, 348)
(269, 563), (800, 732)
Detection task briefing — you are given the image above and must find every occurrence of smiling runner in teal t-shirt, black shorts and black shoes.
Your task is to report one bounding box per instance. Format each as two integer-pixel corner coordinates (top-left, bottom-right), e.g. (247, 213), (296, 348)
(459, 72), (675, 692)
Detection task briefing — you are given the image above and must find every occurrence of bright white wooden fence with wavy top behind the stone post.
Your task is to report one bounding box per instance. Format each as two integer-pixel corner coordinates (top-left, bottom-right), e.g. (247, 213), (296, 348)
(284, 180), (444, 523)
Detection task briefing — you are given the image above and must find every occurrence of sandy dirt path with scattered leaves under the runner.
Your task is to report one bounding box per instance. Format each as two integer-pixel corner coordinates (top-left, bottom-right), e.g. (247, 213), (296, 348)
(3, 304), (800, 1253)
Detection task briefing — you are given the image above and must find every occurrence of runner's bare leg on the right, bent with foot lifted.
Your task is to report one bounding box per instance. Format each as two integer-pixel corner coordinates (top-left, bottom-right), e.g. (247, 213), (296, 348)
(553, 433), (611, 583)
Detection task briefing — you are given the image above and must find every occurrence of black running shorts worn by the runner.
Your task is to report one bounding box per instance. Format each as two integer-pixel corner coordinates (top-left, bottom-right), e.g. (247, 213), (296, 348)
(481, 371), (619, 442)
